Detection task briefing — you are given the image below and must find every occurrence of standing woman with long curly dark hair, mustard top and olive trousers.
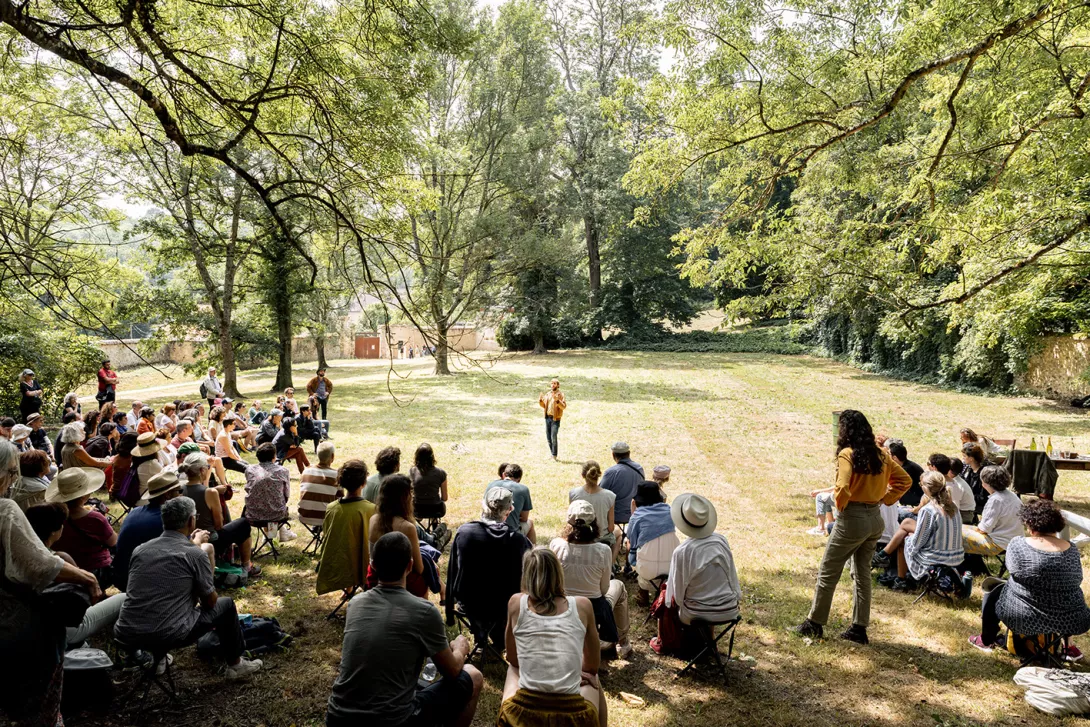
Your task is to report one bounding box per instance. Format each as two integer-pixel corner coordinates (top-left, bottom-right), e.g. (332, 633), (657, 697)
(795, 409), (912, 644)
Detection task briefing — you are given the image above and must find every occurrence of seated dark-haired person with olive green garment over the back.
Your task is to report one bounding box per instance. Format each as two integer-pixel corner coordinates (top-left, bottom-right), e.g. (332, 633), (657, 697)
(317, 459), (375, 595)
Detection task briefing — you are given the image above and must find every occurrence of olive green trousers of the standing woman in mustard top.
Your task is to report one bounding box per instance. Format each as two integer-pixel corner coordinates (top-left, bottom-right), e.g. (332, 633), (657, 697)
(810, 502), (885, 629)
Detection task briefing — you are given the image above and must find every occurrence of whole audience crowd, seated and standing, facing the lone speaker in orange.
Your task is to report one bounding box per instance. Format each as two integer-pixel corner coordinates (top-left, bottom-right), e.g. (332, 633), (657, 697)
(0, 370), (1090, 727)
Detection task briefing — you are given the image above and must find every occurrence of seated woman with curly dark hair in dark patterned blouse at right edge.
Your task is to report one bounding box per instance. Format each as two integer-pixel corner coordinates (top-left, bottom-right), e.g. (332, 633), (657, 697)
(969, 499), (1090, 661)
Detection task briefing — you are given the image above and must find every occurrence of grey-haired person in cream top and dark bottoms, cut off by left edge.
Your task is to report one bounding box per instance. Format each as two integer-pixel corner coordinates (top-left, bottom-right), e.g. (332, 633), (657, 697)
(0, 440), (102, 725)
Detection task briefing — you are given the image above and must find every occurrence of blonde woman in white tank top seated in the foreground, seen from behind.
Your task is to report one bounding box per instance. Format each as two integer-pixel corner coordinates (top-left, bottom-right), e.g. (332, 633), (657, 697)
(496, 548), (608, 727)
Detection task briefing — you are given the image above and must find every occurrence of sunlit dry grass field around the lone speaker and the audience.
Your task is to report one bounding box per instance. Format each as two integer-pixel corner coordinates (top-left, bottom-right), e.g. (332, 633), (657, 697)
(73, 352), (1090, 727)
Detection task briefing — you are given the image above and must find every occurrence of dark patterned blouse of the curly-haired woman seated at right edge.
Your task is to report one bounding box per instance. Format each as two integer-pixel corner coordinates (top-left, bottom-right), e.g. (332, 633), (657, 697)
(995, 537), (1090, 637)
